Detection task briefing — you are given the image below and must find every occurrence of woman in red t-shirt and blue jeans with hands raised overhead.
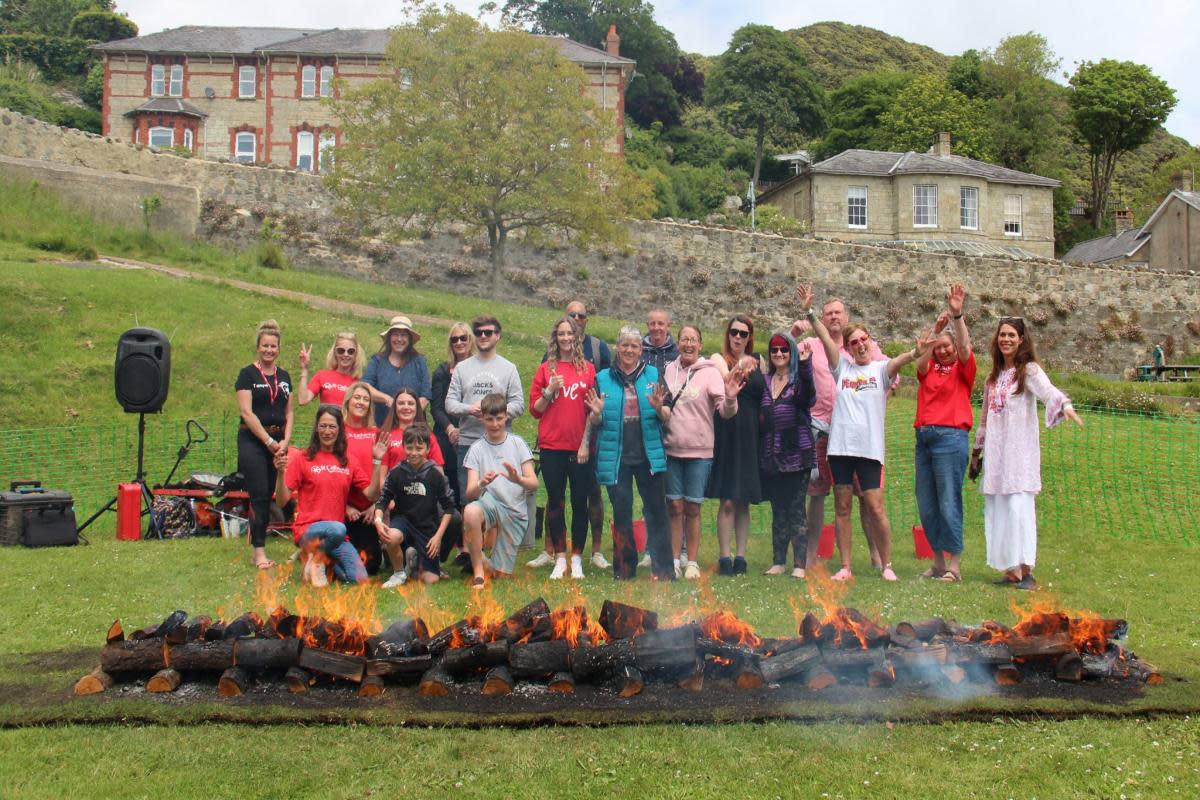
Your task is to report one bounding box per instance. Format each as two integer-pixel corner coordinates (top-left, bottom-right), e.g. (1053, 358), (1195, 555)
(913, 283), (976, 583)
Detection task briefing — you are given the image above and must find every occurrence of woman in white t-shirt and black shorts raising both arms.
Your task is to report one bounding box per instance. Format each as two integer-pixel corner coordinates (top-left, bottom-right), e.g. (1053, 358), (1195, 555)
(796, 285), (929, 581)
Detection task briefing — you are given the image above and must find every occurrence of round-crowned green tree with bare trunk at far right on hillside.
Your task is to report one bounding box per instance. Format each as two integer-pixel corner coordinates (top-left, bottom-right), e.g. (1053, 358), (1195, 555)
(1070, 59), (1175, 228)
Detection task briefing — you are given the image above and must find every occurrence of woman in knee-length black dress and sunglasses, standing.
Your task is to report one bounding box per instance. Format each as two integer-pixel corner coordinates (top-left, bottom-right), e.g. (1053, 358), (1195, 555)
(704, 314), (766, 575)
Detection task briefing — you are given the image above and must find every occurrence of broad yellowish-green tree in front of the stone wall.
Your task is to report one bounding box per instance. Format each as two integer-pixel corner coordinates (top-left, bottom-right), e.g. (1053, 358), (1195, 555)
(329, 7), (648, 275)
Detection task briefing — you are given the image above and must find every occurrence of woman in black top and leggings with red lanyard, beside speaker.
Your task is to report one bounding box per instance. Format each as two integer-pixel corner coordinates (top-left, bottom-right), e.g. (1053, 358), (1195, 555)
(234, 319), (294, 570)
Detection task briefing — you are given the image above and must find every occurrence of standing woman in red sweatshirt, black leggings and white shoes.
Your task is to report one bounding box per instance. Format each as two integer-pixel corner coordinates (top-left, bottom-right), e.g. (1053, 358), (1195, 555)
(529, 317), (596, 581)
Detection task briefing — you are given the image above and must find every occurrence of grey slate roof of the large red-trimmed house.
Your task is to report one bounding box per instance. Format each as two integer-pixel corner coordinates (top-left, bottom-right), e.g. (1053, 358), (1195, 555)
(91, 25), (636, 67)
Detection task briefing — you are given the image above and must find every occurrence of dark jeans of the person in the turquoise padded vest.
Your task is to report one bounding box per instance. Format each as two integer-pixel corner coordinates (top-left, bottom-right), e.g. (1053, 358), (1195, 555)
(607, 461), (674, 581)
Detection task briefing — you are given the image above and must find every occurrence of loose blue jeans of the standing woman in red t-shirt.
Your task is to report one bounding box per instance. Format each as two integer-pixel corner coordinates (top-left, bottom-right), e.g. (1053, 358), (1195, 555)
(917, 425), (968, 553)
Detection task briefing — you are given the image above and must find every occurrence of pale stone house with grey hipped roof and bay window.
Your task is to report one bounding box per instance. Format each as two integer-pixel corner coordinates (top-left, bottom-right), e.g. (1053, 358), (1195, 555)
(757, 133), (1061, 258)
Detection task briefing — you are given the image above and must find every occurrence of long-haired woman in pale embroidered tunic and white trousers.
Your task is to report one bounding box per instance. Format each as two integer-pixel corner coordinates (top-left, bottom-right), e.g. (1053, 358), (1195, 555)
(971, 317), (1084, 590)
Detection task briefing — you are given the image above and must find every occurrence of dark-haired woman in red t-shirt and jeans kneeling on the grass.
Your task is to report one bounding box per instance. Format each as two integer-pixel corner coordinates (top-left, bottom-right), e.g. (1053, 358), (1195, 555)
(275, 405), (383, 584)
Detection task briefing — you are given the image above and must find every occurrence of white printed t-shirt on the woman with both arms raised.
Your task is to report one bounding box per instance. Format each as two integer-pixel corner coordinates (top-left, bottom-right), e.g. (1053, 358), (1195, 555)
(829, 355), (890, 464)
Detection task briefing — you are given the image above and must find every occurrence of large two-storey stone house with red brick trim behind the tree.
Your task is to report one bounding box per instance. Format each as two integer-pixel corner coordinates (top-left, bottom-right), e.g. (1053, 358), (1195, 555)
(92, 25), (635, 172)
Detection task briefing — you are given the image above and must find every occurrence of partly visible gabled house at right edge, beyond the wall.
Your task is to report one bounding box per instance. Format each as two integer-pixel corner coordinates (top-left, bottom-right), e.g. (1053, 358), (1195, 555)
(1062, 173), (1200, 272)
